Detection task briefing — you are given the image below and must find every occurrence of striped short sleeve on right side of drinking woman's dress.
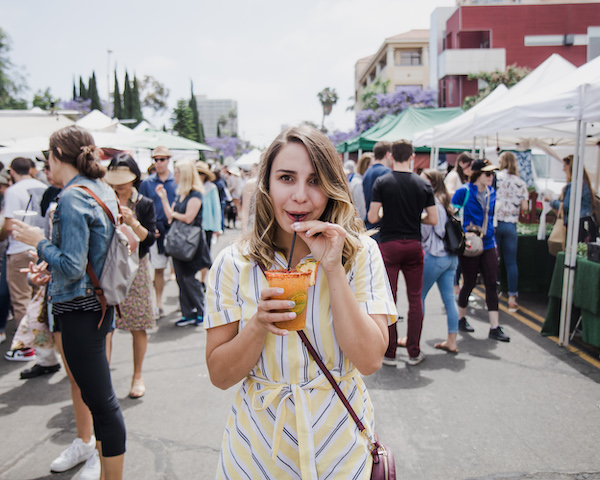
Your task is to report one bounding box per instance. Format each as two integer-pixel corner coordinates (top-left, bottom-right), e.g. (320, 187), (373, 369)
(351, 236), (398, 325)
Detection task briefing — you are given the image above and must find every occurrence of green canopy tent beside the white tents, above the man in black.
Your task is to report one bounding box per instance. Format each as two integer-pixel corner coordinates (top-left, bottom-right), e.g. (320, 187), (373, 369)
(338, 108), (463, 152)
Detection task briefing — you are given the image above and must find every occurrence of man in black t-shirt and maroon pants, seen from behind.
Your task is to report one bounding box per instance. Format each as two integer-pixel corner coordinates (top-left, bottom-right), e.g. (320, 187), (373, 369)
(367, 140), (437, 366)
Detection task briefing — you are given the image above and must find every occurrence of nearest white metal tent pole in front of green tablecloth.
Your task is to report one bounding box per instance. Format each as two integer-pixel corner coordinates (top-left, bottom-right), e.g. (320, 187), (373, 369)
(558, 113), (586, 347)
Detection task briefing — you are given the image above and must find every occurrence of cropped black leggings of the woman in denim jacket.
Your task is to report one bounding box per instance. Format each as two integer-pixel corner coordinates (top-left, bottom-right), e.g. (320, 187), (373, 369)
(57, 308), (125, 457)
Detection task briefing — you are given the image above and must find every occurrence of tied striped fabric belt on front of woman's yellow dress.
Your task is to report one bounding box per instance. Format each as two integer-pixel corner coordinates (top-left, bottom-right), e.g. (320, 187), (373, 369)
(248, 369), (364, 479)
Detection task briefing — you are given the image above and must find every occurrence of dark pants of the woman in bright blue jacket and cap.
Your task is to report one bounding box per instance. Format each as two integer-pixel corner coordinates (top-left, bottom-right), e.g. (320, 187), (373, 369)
(458, 247), (498, 312)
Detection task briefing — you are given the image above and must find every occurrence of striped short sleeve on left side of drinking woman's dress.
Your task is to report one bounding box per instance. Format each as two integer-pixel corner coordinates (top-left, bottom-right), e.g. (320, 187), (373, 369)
(204, 246), (243, 328)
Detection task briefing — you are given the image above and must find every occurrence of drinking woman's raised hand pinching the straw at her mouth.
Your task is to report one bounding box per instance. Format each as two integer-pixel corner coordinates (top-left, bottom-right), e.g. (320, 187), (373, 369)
(292, 220), (346, 272)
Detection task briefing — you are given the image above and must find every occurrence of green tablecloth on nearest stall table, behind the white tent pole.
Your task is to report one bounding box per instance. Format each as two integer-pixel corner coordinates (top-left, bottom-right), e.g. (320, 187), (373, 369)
(542, 252), (600, 347)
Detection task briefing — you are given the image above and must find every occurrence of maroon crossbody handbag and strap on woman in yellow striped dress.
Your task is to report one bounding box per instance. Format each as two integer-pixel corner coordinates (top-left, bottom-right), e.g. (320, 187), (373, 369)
(298, 330), (396, 480)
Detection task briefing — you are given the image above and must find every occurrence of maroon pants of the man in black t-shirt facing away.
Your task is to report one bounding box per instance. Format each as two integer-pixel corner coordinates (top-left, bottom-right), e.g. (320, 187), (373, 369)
(379, 240), (423, 358)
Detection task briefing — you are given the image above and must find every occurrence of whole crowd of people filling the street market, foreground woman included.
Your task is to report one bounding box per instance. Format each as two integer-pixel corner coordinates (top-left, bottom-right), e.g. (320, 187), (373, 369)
(0, 126), (597, 479)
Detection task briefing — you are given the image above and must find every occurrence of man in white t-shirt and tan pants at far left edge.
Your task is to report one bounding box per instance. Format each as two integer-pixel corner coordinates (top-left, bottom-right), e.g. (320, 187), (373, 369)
(0, 157), (48, 327)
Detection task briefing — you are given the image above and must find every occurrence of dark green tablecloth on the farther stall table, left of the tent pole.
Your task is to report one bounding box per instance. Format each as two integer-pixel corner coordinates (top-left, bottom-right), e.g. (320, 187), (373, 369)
(499, 235), (556, 293)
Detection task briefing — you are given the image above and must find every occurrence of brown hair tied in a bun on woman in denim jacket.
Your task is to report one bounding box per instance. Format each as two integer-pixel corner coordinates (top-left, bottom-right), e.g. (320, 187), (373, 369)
(50, 125), (106, 178)
